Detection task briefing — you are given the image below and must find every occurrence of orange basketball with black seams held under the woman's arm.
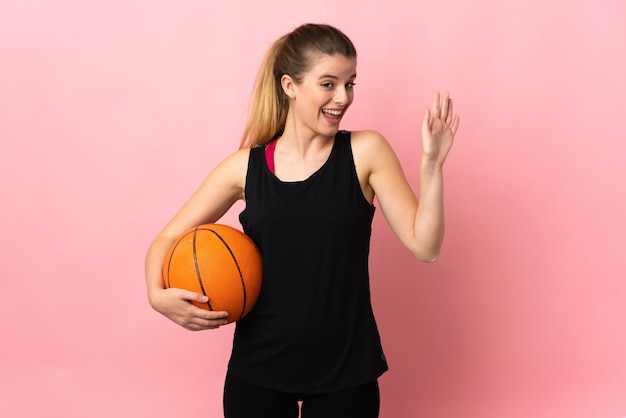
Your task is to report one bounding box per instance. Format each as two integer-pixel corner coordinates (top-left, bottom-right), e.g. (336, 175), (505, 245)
(163, 224), (262, 323)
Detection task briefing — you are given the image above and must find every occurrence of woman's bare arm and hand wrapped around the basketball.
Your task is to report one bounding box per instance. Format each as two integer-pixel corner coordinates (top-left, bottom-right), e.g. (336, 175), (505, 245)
(146, 149), (250, 331)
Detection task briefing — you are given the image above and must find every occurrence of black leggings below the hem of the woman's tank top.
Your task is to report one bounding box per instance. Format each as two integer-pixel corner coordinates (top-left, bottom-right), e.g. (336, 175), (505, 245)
(224, 373), (380, 418)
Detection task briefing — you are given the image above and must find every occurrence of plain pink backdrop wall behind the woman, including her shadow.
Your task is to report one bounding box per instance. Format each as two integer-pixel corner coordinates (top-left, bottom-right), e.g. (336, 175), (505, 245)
(0, 0), (626, 418)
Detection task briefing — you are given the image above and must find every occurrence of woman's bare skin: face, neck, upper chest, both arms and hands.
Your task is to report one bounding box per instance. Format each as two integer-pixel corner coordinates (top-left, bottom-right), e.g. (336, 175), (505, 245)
(146, 55), (459, 331)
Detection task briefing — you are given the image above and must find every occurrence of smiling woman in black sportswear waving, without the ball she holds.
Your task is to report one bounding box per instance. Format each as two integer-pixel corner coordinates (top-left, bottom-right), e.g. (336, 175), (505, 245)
(146, 24), (459, 418)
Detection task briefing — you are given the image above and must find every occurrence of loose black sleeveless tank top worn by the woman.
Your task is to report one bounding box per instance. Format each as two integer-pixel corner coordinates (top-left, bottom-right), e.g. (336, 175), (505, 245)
(229, 131), (387, 394)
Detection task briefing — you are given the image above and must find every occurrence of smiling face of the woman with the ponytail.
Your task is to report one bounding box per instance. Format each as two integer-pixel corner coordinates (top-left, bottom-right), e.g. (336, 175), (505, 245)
(290, 54), (356, 137)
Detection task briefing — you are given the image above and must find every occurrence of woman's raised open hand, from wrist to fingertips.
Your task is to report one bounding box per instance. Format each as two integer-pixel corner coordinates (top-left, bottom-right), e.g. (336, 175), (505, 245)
(422, 92), (460, 164)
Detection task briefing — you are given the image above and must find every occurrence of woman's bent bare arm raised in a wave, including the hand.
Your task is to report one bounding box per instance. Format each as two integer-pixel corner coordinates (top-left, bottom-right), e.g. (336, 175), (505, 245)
(360, 92), (459, 262)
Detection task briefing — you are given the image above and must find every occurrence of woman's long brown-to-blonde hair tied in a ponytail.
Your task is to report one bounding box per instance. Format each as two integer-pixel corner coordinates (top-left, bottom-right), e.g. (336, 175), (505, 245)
(240, 23), (356, 148)
